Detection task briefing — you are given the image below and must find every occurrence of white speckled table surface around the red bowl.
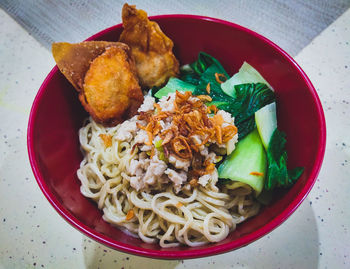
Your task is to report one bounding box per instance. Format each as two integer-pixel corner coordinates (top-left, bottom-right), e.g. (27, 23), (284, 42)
(0, 5), (350, 268)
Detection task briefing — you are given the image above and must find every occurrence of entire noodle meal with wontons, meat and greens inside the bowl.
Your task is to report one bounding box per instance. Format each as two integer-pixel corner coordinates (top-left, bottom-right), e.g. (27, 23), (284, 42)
(53, 5), (302, 247)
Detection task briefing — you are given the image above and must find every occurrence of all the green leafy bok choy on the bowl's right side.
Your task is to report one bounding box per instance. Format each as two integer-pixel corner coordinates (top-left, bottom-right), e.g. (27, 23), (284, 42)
(151, 52), (304, 192)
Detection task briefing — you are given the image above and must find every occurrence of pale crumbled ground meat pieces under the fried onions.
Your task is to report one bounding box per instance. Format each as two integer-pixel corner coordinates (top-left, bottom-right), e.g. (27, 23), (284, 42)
(117, 93), (237, 193)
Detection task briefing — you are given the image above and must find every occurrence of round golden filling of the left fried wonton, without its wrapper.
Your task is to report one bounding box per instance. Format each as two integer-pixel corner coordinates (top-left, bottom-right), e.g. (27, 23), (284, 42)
(79, 47), (143, 125)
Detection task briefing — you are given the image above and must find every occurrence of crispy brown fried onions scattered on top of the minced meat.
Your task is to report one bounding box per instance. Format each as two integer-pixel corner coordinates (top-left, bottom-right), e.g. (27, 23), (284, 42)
(137, 91), (237, 178)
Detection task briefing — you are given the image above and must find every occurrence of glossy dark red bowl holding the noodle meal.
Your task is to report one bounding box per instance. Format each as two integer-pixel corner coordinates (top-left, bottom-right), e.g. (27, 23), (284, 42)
(27, 15), (326, 259)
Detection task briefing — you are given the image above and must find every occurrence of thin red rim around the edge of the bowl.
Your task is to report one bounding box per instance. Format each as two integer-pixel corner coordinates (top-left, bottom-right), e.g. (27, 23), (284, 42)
(27, 14), (326, 259)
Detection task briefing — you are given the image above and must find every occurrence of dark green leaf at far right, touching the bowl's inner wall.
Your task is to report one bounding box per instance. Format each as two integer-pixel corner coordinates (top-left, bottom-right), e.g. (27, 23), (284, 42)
(265, 128), (304, 190)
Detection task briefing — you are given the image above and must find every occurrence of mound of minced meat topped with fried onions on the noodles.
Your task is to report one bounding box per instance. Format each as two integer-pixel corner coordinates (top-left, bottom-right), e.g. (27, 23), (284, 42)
(112, 92), (238, 192)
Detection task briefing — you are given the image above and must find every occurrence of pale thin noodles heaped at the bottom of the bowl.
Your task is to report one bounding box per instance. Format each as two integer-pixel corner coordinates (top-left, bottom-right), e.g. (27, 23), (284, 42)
(77, 116), (259, 248)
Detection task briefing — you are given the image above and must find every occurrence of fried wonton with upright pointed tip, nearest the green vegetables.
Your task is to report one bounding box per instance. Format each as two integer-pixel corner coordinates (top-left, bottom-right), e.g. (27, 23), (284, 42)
(119, 4), (179, 89)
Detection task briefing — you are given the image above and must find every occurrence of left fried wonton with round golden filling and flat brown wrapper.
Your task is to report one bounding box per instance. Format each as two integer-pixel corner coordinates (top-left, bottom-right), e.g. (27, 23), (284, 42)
(52, 41), (143, 126)
